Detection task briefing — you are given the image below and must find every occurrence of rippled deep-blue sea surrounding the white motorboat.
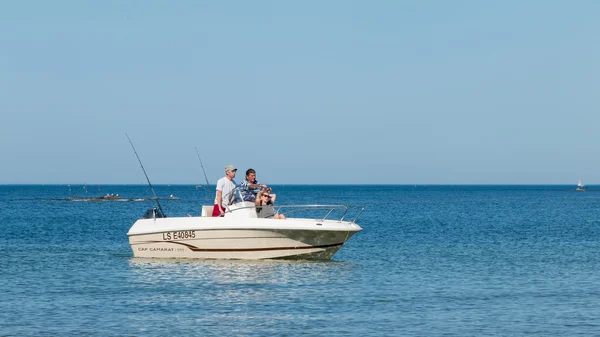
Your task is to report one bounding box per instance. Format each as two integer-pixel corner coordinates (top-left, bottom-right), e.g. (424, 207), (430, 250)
(0, 185), (600, 336)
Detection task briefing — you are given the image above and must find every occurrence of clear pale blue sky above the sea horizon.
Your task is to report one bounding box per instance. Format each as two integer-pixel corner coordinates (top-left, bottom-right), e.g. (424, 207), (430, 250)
(0, 0), (600, 184)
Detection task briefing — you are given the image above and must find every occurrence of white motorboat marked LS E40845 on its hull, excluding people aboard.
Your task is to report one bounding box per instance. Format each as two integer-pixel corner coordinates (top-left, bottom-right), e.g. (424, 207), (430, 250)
(127, 191), (364, 260)
